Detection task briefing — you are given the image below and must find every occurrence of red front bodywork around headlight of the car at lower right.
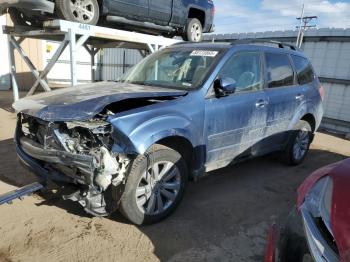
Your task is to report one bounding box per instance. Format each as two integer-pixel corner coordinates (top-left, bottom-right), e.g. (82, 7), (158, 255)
(298, 158), (350, 261)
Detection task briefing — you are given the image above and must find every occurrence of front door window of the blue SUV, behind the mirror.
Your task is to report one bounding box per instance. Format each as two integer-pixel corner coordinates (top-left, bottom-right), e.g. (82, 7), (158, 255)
(219, 52), (262, 92)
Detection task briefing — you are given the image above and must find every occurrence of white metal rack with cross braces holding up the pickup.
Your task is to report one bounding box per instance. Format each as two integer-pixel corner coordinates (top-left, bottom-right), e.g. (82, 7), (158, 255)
(2, 20), (181, 101)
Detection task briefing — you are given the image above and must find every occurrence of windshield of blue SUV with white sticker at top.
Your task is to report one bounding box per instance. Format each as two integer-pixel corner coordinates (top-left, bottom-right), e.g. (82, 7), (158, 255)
(120, 49), (220, 90)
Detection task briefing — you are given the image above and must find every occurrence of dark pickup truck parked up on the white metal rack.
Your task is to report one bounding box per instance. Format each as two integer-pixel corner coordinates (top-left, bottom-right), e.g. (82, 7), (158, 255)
(0, 0), (215, 42)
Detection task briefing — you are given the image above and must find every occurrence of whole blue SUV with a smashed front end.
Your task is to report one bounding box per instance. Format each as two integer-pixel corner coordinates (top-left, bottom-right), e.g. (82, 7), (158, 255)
(14, 42), (323, 224)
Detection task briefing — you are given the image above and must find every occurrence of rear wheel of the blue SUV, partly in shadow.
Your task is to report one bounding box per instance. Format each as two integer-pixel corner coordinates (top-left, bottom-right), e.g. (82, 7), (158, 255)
(283, 120), (312, 165)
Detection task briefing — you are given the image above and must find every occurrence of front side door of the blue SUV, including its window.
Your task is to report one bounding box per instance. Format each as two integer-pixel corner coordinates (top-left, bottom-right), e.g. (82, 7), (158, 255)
(205, 51), (268, 171)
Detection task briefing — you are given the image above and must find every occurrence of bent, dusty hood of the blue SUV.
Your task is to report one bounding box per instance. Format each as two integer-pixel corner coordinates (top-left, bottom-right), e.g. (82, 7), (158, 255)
(13, 82), (187, 122)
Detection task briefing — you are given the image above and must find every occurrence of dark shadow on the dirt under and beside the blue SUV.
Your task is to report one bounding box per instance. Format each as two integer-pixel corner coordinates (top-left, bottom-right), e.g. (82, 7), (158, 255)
(0, 136), (346, 261)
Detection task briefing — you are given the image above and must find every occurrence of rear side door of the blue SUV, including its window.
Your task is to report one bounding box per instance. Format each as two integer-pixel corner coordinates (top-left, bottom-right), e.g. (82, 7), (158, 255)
(264, 52), (305, 151)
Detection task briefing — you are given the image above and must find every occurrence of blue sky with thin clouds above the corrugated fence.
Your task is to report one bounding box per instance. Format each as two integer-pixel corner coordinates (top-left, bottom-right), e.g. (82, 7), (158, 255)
(214, 0), (350, 33)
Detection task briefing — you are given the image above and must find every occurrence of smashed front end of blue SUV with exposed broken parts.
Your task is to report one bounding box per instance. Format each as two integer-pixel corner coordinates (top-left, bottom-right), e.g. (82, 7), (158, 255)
(16, 114), (130, 216)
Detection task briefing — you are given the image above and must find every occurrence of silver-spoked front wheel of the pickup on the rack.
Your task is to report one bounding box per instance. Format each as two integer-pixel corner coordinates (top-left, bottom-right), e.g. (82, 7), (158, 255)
(56, 0), (100, 25)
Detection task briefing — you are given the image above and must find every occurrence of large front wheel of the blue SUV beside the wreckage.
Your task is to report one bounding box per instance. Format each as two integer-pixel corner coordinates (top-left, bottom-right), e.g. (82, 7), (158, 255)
(119, 145), (188, 225)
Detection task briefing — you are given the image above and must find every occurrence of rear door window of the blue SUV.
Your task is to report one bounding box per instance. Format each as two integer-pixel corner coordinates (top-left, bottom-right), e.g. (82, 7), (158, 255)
(265, 53), (294, 88)
